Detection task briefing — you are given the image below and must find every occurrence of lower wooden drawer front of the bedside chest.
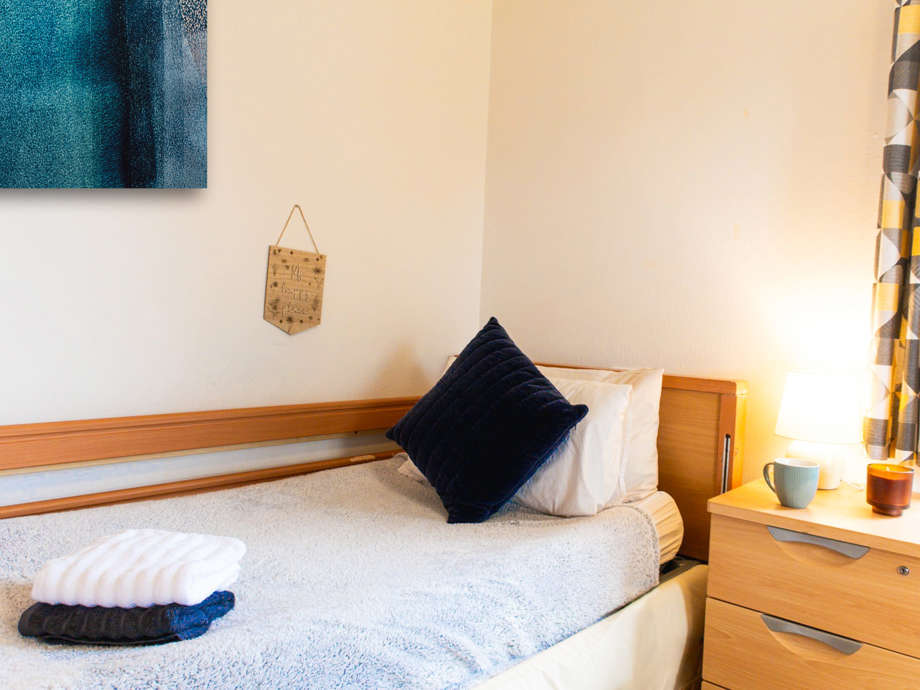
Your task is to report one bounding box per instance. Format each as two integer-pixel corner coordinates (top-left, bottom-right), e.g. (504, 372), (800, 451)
(703, 599), (920, 690)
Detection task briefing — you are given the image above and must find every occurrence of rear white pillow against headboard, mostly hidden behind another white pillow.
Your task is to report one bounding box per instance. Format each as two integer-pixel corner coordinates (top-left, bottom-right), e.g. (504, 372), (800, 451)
(537, 367), (664, 503)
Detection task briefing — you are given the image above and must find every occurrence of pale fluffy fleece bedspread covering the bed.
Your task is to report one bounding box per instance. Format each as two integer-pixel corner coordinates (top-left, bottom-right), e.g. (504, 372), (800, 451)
(0, 460), (658, 690)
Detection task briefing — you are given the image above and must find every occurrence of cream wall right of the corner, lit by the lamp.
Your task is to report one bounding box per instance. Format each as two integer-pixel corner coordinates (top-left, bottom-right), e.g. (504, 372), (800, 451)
(480, 0), (893, 478)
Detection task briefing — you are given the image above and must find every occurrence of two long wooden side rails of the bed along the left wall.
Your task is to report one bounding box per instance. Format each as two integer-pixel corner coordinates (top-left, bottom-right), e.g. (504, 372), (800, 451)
(0, 397), (418, 518)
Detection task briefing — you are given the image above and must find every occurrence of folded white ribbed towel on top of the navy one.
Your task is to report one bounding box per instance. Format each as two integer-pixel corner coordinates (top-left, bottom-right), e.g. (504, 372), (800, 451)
(32, 529), (246, 608)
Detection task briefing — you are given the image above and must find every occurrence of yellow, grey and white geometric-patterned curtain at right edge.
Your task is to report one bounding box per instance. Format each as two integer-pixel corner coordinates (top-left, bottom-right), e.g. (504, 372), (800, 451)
(865, 0), (920, 462)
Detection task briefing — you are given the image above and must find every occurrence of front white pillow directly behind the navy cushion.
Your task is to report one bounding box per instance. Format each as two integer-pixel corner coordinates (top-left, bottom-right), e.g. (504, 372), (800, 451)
(514, 378), (631, 517)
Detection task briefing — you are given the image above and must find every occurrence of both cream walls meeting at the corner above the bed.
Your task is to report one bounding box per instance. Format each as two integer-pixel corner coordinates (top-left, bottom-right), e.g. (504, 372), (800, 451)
(0, 0), (891, 498)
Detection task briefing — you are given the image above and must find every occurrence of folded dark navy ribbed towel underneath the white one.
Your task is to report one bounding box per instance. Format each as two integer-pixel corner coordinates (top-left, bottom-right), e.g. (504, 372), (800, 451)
(19, 592), (234, 645)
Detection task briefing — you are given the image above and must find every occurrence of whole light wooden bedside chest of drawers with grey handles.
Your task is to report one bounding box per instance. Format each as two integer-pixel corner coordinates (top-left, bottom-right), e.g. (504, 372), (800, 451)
(703, 480), (920, 689)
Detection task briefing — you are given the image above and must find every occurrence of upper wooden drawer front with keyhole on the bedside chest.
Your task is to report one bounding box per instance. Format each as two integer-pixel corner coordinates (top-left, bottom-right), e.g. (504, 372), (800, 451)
(708, 515), (920, 657)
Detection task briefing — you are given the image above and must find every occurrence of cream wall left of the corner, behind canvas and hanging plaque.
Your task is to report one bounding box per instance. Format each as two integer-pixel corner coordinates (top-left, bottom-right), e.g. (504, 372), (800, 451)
(0, 0), (491, 424)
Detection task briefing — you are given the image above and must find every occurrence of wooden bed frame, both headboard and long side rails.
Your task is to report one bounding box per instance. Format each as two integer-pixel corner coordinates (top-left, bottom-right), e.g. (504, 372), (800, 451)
(0, 365), (746, 560)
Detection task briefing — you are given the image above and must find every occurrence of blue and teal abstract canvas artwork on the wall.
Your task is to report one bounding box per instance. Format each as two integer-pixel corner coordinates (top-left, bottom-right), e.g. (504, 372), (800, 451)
(0, 0), (208, 188)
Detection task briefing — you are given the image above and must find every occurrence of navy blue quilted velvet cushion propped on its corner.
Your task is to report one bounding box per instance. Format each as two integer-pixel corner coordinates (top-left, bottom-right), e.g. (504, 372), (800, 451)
(387, 317), (588, 522)
